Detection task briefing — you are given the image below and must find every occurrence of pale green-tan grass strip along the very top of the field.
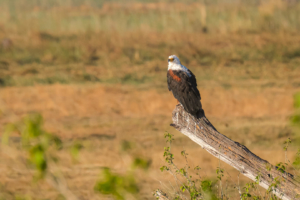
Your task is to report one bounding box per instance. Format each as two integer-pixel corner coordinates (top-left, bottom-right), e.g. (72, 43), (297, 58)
(0, 0), (300, 33)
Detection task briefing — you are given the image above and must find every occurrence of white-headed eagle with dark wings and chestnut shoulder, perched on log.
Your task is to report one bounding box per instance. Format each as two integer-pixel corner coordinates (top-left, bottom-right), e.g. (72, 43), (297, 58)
(167, 55), (202, 118)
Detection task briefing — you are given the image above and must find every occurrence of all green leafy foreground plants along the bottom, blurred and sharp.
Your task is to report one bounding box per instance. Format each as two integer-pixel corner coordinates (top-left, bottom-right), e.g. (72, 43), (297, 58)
(2, 115), (300, 200)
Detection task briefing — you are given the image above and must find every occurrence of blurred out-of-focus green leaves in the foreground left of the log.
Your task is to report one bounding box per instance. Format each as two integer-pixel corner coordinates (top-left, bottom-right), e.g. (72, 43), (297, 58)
(0, 114), (151, 199)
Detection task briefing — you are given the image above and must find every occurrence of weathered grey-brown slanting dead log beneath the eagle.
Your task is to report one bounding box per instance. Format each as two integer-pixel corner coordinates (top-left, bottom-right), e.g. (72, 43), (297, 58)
(171, 104), (300, 200)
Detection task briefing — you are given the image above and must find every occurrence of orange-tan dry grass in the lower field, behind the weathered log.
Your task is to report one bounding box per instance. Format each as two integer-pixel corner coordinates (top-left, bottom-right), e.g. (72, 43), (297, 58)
(1, 84), (295, 199)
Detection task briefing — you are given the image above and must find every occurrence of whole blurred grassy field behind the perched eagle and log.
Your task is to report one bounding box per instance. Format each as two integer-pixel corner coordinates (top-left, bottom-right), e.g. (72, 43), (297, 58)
(0, 0), (300, 199)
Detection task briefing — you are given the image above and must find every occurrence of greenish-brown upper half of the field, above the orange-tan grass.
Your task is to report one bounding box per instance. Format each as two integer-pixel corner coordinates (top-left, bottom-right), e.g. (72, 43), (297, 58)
(0, 0), (300, 88)
